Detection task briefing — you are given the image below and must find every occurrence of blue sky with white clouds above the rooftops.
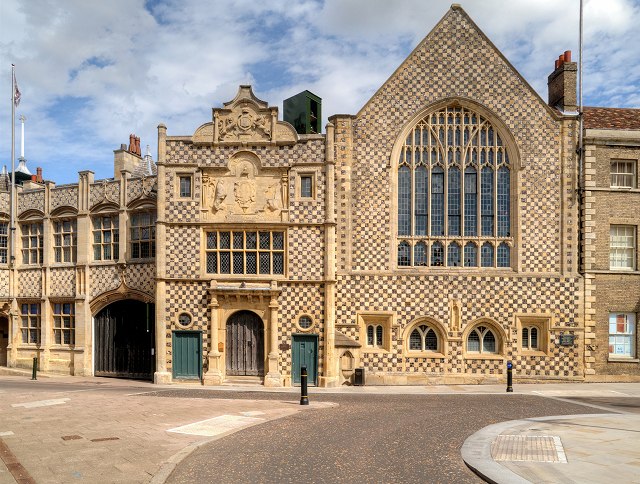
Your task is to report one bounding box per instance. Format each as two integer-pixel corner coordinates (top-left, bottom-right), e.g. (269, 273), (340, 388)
(0, 0), (640, 184)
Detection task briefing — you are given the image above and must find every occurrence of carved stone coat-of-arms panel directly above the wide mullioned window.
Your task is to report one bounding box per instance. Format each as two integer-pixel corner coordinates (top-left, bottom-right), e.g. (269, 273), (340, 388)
(202, 152), (288, 222)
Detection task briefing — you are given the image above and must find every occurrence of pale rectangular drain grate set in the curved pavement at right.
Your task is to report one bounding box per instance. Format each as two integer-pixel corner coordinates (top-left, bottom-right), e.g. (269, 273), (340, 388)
(491, 435), (567, 464)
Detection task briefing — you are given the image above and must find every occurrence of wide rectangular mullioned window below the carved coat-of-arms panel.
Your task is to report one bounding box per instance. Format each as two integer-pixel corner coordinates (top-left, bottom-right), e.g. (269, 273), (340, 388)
(205, 230), (285, 274)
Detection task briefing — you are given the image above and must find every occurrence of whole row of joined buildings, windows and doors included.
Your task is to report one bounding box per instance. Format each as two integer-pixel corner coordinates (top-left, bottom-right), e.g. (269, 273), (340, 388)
(0, 5), (640, 386)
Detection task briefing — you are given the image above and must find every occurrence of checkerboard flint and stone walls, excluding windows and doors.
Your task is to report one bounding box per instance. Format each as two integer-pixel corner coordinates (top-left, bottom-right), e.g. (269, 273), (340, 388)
(0, 6), (637, 386)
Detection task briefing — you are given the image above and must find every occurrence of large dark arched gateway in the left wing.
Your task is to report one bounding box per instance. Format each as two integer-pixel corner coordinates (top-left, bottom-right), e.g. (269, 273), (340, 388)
(94, 299), (155, 380)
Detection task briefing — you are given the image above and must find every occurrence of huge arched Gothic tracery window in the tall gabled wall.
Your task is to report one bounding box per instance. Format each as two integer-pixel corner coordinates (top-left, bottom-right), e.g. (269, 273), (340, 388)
(397, 106), (513, 267)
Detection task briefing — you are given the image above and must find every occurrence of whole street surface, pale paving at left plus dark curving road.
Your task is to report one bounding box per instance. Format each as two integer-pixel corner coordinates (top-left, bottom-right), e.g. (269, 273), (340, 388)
(0, 376), (640, 484)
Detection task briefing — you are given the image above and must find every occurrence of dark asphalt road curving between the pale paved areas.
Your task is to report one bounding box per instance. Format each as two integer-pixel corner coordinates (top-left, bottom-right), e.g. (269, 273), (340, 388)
(157, 391), (600, 483)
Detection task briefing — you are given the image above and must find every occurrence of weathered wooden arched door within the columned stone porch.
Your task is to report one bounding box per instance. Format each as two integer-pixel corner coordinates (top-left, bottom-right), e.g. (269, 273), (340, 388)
(226, 311), (264, 376)
